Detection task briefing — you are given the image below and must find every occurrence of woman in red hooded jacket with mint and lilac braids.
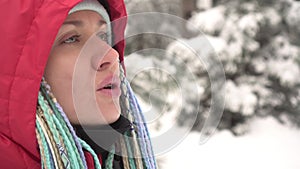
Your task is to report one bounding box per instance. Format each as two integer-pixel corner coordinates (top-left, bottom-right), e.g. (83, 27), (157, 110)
(0, 0), (156, 168)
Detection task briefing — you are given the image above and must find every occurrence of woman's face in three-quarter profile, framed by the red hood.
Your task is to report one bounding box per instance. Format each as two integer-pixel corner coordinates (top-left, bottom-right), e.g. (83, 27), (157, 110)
(44, 10), (120, 125)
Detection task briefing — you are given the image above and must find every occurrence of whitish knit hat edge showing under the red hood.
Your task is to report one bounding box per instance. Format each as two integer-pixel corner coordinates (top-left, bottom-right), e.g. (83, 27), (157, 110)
(69, 0), (112, 45)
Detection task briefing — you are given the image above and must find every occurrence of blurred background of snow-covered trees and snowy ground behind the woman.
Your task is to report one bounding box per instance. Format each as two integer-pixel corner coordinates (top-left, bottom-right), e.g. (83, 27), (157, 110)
(125, 0), (300, 169)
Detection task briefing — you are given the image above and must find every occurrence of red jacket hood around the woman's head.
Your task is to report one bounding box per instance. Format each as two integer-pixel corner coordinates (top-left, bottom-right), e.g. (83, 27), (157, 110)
(0, 0), (126, 168)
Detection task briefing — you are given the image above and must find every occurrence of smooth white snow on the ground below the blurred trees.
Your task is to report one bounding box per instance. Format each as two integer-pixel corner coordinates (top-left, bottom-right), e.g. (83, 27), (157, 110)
(157, 117), (300, 169)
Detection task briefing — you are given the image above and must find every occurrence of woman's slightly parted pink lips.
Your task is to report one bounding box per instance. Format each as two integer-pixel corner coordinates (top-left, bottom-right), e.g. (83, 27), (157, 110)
(96, 75), (121, 98)
